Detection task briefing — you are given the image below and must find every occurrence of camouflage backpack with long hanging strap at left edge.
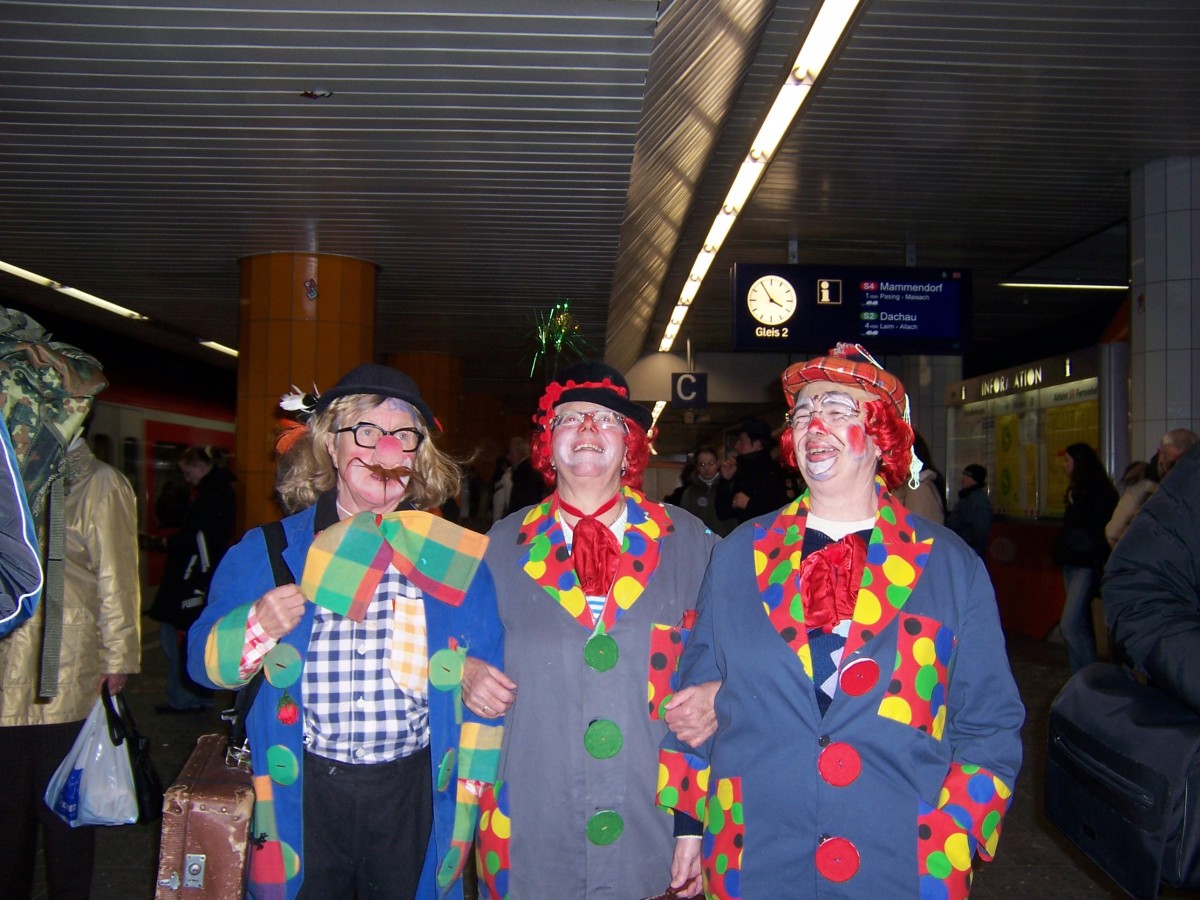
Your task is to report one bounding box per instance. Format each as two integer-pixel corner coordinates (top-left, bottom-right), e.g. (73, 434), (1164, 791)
(0, 306), (108, 698)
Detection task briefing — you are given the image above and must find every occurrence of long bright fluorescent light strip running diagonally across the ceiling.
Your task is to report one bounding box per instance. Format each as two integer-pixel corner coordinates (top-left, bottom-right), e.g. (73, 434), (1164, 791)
(654, 0), (859, 355)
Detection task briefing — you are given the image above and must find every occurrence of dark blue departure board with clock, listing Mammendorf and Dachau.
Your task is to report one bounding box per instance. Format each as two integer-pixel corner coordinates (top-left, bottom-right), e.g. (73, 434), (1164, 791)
(732, 263), (971, 354)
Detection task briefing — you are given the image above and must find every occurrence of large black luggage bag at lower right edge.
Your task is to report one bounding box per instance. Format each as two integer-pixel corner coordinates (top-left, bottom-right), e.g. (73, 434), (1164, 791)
(1045, 662), (1200, 900)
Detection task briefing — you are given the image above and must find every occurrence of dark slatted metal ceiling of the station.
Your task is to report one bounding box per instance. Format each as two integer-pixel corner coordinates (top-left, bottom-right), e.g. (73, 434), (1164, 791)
(0, 0), (1200, 451)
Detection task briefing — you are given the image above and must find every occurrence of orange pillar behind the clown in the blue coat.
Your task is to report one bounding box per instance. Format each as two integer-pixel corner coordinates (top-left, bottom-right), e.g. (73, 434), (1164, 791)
(236, 253), (377, 529)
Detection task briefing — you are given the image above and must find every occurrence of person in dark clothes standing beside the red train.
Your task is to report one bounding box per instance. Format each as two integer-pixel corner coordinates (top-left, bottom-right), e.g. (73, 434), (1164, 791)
(149, 446), (238, 714)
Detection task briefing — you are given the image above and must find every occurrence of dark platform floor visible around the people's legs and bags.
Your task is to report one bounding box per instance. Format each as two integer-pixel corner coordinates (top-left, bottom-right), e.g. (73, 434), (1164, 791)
(35, 620), (1171, 900)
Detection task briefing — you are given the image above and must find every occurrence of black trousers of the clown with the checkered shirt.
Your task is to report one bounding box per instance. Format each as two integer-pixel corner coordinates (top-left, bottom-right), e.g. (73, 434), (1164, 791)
(298, 748), (433, 900)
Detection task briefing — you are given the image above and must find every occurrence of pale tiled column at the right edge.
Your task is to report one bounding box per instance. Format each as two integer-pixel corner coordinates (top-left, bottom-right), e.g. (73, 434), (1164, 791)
(1129, 156), (1200, 460)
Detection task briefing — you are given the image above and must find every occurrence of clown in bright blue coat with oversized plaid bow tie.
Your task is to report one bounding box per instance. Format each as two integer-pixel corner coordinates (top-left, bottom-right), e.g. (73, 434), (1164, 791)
(188, 364), (502, 900)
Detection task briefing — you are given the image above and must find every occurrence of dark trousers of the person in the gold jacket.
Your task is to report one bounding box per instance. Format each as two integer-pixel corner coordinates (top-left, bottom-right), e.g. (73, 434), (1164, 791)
(0, 721), (96, 900)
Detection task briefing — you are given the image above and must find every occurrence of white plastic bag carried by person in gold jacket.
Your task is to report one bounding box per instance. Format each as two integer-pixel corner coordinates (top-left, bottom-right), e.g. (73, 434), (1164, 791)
(44, 698), (138, 828)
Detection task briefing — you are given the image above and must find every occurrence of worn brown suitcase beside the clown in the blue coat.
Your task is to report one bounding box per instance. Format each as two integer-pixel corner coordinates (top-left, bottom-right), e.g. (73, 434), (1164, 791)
(155, 734), (254, 900)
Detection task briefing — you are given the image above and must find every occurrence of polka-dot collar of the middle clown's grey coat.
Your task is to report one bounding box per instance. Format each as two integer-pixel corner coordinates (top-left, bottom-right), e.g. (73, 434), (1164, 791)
(517, 487), (674, 631)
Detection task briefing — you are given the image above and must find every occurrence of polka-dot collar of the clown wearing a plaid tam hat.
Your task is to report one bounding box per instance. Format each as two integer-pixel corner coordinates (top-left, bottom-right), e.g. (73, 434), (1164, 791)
(754, 479), (934, 678)
